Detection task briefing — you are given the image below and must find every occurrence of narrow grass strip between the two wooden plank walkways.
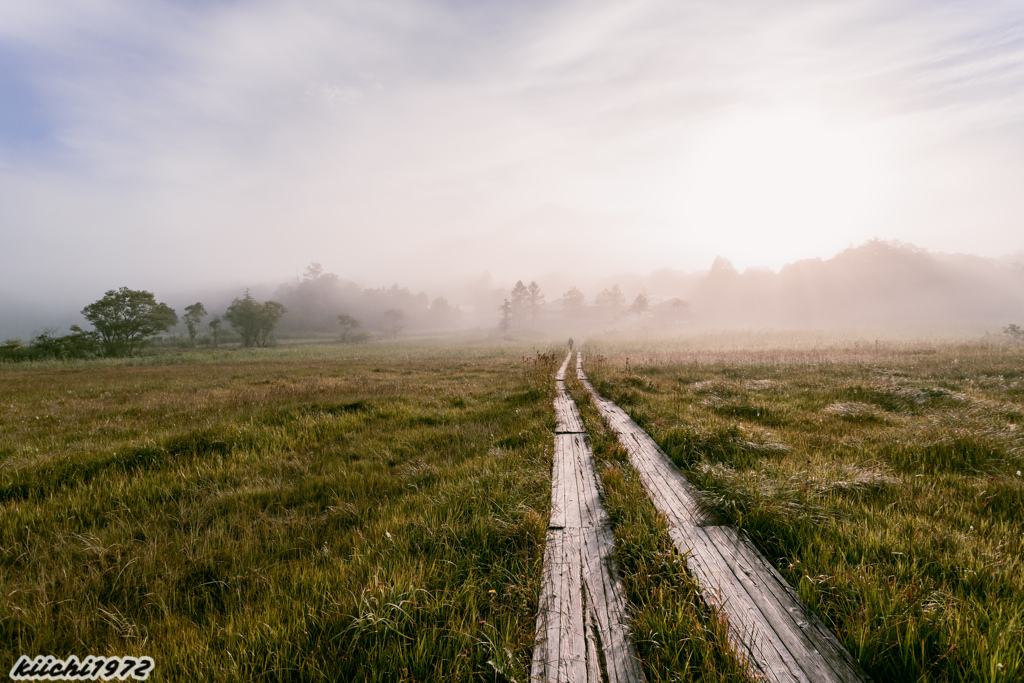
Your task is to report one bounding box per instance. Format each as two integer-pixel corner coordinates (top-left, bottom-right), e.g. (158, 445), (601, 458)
(565, 359), (751, 683)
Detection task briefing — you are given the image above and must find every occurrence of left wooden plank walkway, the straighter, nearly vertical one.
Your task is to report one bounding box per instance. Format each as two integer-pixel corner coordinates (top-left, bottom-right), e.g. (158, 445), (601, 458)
(530, 353), (644, 683)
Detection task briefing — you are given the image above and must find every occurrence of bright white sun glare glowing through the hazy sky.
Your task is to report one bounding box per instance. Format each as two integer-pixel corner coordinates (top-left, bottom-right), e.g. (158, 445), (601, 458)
(671, 108), (892, 265)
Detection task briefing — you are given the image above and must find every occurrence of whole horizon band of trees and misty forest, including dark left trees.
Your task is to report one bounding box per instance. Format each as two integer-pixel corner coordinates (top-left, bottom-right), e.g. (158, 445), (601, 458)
(0, 240), (1024, 360)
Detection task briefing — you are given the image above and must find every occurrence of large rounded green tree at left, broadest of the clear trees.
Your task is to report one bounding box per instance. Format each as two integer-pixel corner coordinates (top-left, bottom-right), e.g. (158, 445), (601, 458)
(82, 287), (178, 356)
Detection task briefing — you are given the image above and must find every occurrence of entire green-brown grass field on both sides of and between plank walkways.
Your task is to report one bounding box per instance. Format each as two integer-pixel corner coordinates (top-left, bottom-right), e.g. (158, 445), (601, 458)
(0, 335), (1024, 683)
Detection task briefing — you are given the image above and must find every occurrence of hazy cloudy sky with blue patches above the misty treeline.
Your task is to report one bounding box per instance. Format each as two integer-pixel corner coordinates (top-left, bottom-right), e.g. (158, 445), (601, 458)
(0, 0), (1024, 305)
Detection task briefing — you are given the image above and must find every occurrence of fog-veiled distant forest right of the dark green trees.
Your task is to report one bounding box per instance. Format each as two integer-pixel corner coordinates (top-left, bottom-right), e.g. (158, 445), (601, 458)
(274, 240), (1024, 335)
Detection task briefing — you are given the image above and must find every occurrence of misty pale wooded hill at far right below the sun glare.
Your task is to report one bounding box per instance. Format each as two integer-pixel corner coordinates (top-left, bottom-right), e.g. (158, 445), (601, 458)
(689, 240), (1024, 326)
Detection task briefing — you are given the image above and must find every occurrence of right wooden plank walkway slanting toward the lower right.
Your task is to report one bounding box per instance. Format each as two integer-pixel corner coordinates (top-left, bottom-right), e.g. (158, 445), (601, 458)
(577, 353), (869, 683)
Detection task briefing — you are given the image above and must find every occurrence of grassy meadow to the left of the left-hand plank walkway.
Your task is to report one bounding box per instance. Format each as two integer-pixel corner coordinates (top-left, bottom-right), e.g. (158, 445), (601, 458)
(0, 344), (557, 681)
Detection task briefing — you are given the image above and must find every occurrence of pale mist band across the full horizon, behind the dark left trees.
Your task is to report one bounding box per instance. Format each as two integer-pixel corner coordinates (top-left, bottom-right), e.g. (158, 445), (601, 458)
(0, 240), (1024, 340)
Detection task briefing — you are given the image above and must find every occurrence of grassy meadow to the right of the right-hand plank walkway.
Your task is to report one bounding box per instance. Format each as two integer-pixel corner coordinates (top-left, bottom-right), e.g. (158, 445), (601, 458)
(585, 343), (1024, 681)
